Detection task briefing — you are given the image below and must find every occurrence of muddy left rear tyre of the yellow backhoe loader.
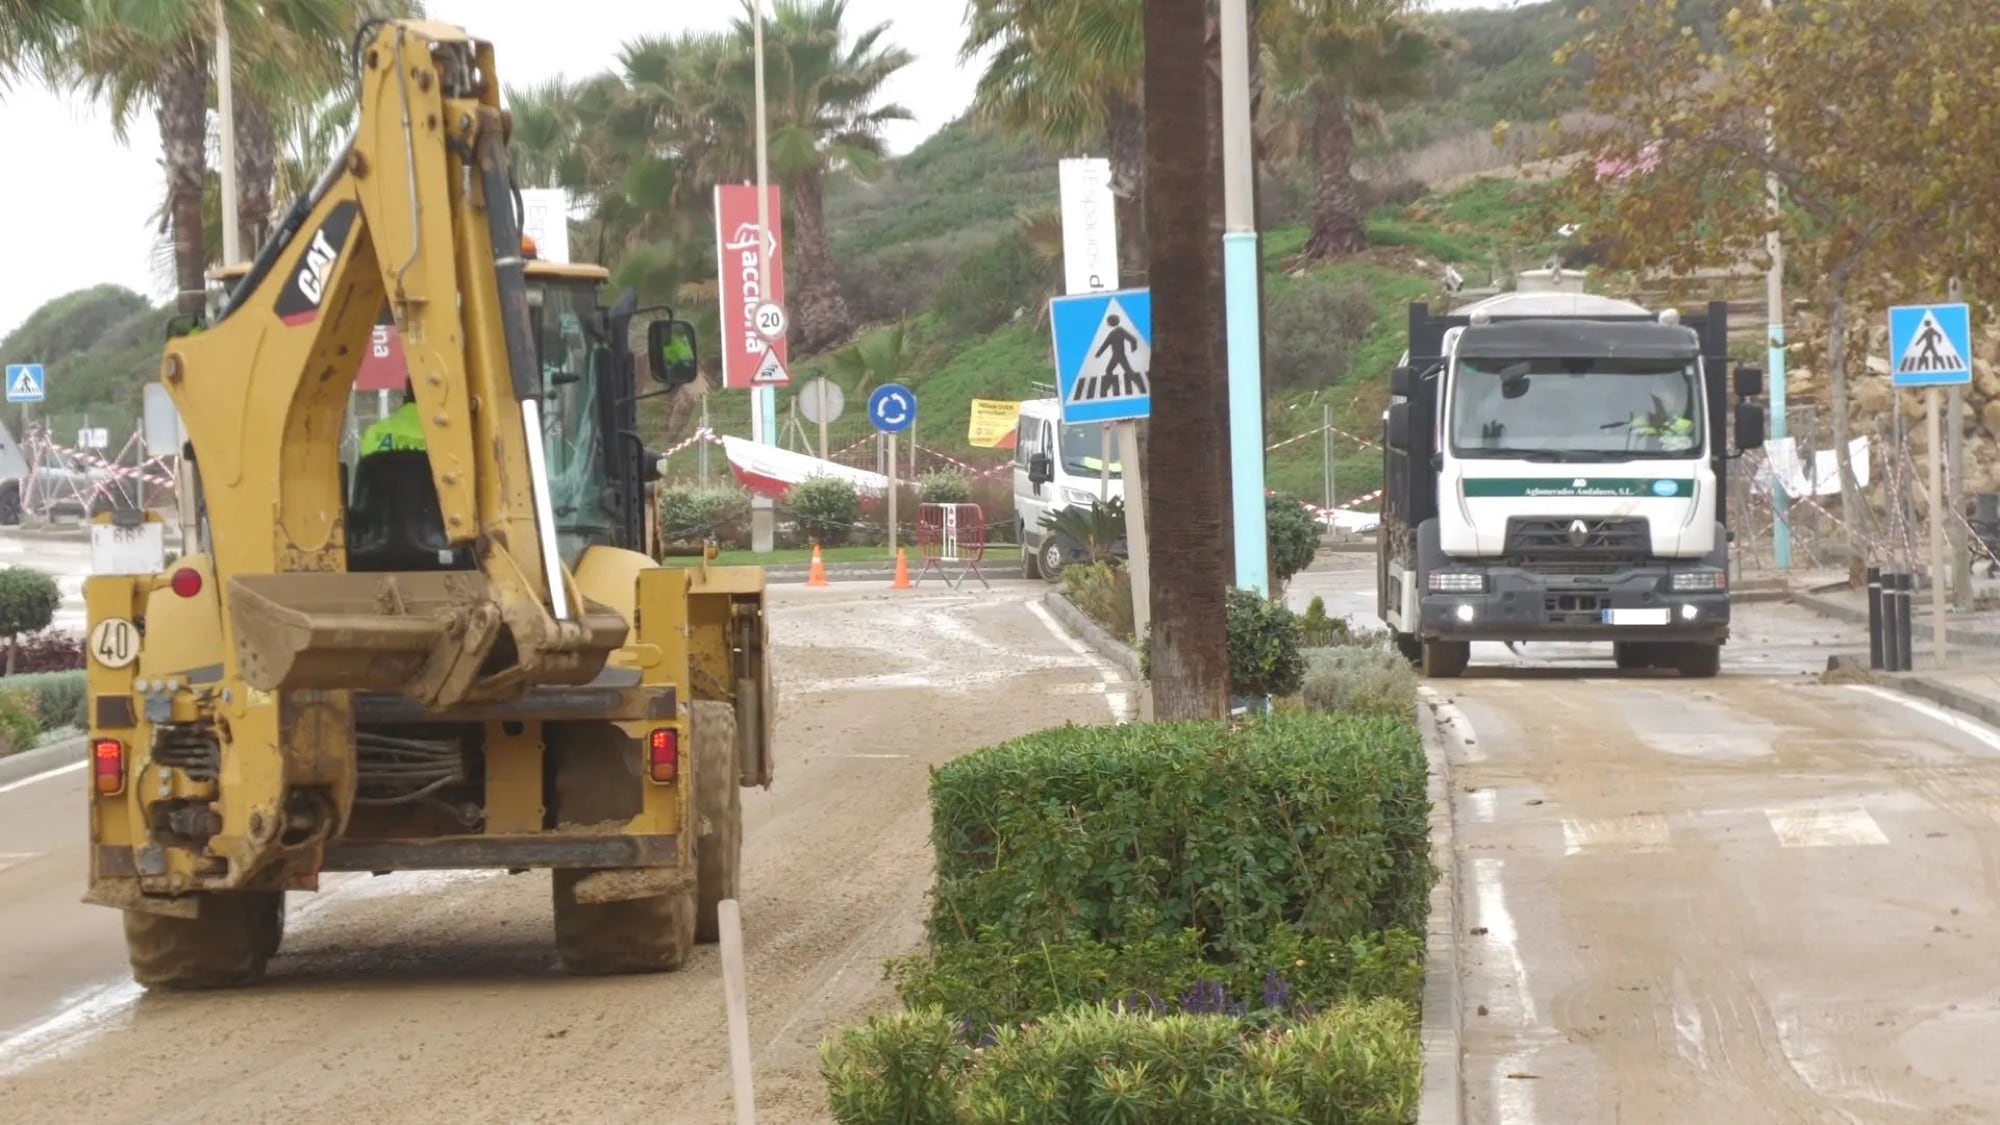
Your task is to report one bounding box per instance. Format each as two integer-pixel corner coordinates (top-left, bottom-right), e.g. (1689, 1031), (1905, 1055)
(126, 891), (284, 991)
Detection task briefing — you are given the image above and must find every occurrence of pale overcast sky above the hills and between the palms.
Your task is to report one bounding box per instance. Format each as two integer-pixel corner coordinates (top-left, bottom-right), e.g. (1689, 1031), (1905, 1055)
(0, 0), (1520, 342)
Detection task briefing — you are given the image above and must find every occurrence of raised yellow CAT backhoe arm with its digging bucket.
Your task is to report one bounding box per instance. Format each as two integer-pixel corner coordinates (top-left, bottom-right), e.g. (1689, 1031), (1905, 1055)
(162, 20), (626, 707)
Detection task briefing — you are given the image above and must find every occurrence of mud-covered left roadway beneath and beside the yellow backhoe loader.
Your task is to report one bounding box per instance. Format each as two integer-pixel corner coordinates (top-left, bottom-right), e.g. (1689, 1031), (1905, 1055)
(0, 583), (1126, 1125)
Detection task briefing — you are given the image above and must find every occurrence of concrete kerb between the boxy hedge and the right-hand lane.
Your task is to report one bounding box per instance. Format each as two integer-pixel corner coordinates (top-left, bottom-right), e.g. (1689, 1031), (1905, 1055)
(1416, 691), (1466, 1125)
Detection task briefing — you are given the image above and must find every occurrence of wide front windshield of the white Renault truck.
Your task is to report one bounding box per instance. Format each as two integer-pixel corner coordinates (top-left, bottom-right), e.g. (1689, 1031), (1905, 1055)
(1450, 356), (1704, 460)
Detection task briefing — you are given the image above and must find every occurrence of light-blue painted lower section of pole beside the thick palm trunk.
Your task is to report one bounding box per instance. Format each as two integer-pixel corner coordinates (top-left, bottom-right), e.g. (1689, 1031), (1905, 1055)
(1222, 230), (1270, 597)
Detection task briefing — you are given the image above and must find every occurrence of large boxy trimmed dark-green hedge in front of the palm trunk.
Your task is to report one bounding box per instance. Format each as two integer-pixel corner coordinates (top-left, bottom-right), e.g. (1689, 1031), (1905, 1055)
(928, 713), (1436, 961)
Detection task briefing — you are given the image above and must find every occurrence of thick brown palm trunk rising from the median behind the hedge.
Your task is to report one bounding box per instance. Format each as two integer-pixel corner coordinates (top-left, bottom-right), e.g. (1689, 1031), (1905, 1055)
(1144, 0), (1230, 721)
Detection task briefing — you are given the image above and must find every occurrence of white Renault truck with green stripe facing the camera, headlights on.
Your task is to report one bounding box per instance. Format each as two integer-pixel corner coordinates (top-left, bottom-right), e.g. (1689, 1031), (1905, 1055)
(1378, 276), (1764, 677)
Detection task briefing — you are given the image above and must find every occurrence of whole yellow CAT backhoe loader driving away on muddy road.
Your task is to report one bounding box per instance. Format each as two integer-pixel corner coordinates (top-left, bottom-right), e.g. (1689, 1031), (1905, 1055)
(84, 20), (774, 987)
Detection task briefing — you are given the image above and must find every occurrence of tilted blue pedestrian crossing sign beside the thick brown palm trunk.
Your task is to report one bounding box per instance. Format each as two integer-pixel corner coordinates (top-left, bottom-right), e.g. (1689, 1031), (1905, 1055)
(1048, 288), (1152, 426)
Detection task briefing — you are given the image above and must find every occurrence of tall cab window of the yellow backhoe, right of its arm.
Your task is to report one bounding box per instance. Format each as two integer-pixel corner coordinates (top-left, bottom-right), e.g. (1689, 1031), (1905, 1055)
(528, 280), (612, 567)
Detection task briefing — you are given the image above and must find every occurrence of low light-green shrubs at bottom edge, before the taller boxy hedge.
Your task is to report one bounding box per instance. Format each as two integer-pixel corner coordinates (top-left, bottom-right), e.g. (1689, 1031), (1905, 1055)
(820, 1001), (1422, 1125)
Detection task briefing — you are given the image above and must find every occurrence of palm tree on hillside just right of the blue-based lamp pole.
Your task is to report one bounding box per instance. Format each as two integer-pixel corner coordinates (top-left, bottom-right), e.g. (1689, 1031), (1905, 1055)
(1260, 0), (1444, 260)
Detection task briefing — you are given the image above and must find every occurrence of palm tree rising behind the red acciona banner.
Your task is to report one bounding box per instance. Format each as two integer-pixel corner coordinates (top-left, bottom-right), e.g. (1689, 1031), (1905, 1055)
(680, 0), (914, 350)
